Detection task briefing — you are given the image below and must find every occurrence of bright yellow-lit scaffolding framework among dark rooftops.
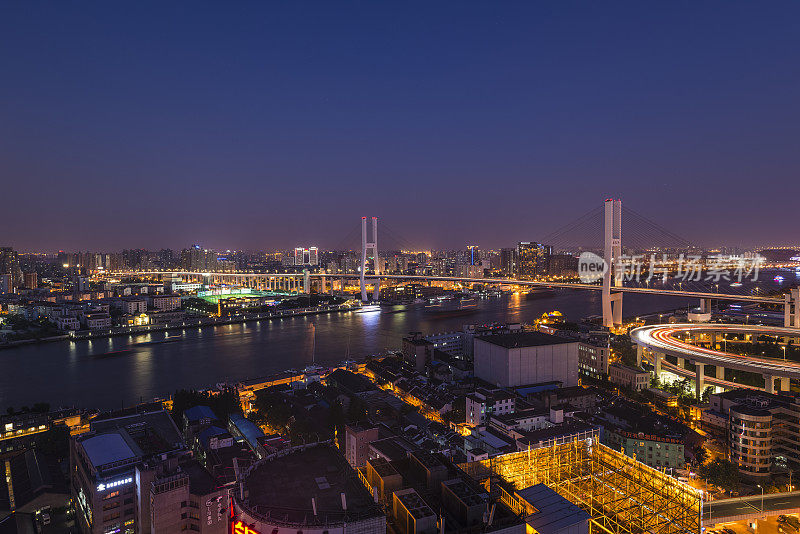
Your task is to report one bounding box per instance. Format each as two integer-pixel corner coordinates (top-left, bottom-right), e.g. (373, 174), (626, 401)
(461, 439), (702, 534)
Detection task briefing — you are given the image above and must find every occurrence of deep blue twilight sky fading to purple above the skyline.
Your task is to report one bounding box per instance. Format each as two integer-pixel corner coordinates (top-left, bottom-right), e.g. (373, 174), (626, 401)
(0, 0), (800, 251)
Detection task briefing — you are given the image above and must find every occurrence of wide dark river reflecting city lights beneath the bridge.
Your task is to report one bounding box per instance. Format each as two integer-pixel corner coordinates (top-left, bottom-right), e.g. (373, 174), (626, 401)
(0, 290), (697, 411)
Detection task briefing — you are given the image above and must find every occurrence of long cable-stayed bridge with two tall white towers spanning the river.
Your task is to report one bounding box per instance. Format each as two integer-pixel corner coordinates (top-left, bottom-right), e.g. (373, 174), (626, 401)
(111, 199), (800, 327)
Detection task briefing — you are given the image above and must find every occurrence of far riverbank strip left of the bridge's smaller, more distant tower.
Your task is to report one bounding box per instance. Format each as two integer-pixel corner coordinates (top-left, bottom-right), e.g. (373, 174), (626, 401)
(0, 304), (361, 349)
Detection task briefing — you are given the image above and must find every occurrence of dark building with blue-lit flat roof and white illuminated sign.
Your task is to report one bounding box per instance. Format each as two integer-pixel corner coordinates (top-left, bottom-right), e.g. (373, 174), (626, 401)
(70, 411), (189, 534)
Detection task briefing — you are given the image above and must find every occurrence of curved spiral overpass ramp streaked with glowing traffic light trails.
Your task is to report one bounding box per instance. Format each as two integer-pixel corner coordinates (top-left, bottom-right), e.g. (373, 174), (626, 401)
(631, 323), (800, 392)
